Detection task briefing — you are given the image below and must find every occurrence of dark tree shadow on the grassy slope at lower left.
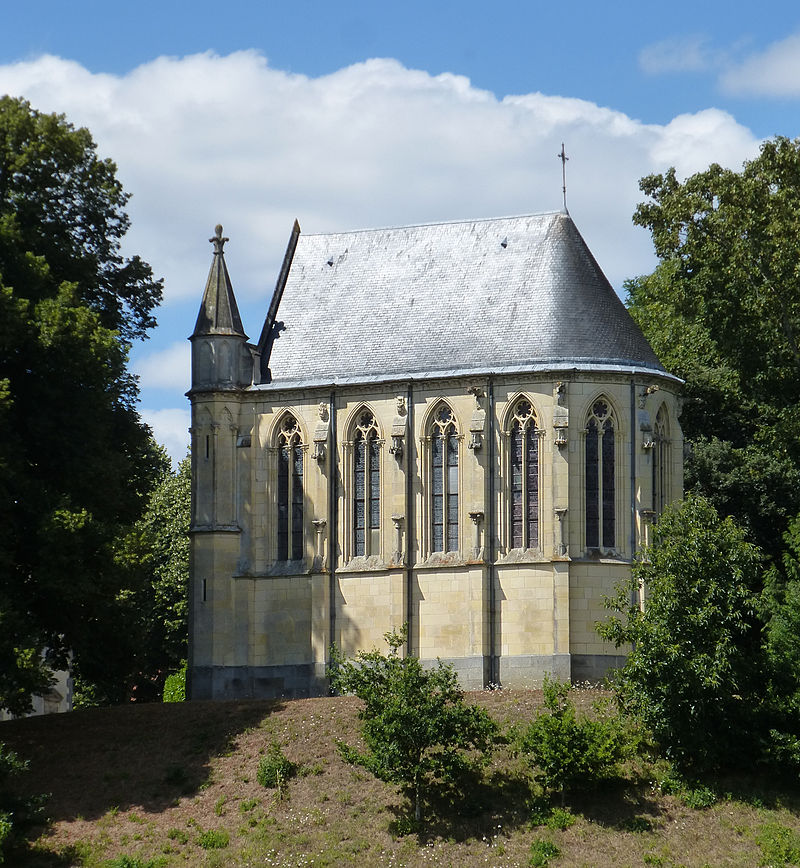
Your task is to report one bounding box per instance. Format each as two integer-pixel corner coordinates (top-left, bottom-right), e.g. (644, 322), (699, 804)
(0, 700), (283, 824)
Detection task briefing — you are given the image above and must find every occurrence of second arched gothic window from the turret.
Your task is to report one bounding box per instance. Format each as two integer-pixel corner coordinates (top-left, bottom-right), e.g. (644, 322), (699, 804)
(353, 410), (381, 556)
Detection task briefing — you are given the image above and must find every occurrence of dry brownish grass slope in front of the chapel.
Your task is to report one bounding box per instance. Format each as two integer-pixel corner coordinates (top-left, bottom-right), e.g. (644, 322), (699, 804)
(0, 691), (800, 868)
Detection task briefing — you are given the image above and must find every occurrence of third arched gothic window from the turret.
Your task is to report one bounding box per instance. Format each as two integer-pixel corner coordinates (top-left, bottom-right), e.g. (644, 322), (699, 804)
(430, 404), (458, 552)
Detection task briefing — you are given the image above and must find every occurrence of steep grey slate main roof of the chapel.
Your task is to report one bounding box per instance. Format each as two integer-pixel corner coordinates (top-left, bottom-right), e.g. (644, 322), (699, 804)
(259, 212), (666, 387)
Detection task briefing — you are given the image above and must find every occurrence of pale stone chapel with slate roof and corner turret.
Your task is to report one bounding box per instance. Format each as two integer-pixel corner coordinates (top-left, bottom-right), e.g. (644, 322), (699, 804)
(188, 211), (683, 699)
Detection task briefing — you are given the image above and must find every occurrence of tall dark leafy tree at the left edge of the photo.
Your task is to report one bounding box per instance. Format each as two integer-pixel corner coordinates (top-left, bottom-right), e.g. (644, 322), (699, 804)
(0, 97), (163, 711)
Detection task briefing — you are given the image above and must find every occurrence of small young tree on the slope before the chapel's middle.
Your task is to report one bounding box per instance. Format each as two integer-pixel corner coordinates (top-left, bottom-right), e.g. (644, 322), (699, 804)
(329, 627), (497, 822)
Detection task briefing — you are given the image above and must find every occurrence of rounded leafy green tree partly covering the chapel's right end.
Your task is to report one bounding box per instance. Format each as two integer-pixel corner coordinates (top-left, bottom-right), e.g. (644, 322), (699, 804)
(598, 494), (768, 773)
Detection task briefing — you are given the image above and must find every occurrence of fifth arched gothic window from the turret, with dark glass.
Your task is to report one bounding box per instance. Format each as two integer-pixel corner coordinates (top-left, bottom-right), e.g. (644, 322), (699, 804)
(585, 398), (616, 549)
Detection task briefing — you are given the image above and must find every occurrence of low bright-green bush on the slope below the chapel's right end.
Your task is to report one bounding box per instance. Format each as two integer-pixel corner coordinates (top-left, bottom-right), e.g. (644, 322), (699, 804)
(520, 678), (626, 806)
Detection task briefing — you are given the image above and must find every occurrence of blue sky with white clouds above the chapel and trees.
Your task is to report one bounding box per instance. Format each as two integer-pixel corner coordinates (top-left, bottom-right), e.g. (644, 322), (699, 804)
(0, 0), (800, 460)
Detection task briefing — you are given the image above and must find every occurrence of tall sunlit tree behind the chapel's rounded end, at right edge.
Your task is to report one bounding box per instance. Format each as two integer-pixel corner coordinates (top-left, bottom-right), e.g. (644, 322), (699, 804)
(626, 138), (800, 558)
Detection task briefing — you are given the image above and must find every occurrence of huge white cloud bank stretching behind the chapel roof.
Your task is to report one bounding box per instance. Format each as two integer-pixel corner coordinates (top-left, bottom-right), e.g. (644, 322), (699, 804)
(0, 51), (758, 420)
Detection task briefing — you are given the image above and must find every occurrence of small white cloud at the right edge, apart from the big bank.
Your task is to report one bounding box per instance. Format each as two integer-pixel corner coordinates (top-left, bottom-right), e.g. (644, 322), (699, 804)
(720, 33), (800, 97)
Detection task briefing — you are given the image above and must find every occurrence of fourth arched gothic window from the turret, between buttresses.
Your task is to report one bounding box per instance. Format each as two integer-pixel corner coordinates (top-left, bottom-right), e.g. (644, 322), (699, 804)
(508, 398), (539, 549)
